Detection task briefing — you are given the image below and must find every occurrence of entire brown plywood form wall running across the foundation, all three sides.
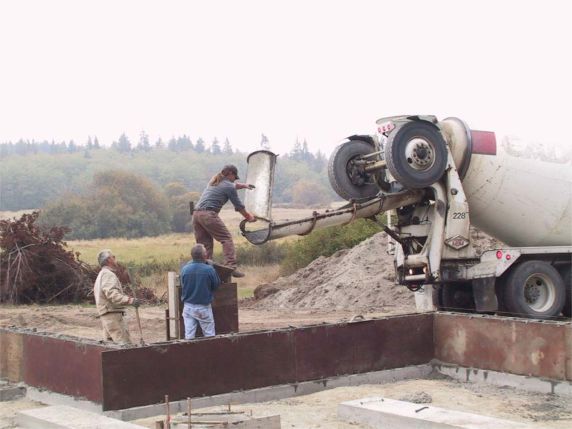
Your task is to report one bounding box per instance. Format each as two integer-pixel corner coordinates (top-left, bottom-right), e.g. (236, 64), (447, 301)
(0, 313), (572, 410)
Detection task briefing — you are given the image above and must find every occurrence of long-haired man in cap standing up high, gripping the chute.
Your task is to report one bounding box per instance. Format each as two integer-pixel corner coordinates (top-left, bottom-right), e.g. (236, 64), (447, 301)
(193, 164), (256, 277)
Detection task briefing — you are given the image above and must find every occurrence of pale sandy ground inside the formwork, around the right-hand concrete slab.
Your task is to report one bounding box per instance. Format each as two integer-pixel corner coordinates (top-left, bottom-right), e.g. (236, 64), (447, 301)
(133, 377), (572, 429)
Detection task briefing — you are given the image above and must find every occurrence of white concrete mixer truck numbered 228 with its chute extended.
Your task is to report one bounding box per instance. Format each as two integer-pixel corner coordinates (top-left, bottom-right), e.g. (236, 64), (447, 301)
(241, 115), (572, 319)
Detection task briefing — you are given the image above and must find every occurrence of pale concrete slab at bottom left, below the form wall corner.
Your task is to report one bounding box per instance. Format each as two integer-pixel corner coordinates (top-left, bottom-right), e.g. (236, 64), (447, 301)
(16, 405), (143, 429)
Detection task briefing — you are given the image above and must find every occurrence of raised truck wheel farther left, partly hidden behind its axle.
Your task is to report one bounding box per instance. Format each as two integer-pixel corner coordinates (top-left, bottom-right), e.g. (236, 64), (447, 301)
(328, 140), (379, 200)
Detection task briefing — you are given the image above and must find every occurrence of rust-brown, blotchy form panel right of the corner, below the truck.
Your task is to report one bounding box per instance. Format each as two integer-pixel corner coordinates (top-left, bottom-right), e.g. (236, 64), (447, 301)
(434, 313), (572, 380)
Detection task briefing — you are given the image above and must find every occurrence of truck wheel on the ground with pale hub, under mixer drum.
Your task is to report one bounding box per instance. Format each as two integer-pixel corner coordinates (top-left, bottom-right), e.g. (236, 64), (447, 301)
(504, 261), (566, 319)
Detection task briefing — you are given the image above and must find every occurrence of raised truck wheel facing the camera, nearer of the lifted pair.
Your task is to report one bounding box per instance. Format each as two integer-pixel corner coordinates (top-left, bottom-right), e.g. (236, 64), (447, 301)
(385, 122), (447, 189)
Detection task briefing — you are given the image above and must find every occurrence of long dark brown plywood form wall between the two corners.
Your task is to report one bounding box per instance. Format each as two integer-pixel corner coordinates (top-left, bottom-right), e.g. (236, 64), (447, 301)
(102, 314), (433, 410)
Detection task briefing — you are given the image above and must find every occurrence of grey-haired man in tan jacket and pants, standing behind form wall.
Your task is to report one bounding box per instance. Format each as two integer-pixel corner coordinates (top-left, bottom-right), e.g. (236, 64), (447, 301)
(93, 249), (141, 344)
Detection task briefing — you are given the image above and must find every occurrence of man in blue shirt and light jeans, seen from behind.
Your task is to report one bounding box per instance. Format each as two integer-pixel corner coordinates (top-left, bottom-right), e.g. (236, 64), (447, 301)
(181, 244), (220, 340)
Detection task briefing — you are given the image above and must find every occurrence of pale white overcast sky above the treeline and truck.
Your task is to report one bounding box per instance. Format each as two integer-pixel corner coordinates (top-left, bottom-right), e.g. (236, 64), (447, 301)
(0, 0), (572, 153)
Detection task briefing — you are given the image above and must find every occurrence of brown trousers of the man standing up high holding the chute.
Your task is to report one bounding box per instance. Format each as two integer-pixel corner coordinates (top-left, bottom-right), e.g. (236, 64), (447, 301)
(193, 210), (236, 268)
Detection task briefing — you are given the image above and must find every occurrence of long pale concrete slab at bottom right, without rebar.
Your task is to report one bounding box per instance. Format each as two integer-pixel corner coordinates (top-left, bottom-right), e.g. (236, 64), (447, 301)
(338, 397), (538, 429)
